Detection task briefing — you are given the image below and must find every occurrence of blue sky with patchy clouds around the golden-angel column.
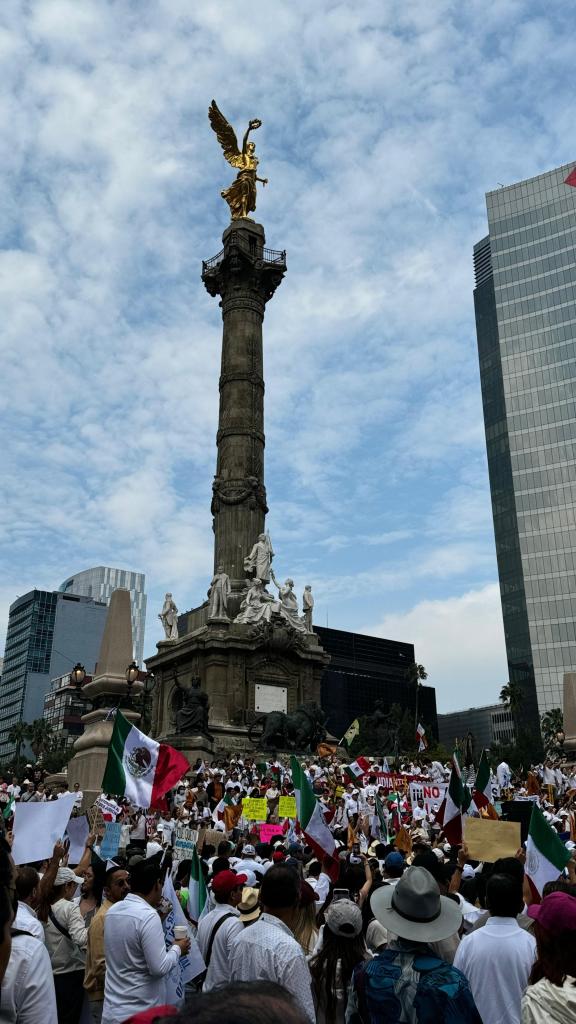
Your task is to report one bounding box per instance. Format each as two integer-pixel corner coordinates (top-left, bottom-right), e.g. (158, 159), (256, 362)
(0, 0), (576, 711)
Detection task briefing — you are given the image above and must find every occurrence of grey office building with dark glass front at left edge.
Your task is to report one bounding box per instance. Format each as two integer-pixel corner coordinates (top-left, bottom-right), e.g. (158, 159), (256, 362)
(0, 590), (108, 761)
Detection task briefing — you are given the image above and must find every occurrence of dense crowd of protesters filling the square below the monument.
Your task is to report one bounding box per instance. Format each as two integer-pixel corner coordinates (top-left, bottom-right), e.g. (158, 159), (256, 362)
(0, 757), (576, 1024)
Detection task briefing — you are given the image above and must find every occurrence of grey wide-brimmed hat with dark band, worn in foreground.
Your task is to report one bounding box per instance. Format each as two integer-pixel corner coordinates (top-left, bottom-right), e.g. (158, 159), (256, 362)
(370, 867), (462, 942)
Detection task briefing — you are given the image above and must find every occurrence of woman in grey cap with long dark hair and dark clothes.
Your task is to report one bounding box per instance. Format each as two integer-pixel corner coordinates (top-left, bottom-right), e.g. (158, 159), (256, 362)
(310, 899), (370, 1024)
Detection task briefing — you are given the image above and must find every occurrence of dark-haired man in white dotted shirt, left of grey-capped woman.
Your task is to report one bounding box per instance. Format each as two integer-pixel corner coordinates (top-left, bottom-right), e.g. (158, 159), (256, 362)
(231, 864), (316, 1024)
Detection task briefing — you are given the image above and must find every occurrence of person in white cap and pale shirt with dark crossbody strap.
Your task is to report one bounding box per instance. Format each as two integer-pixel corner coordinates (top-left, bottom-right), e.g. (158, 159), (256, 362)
(36, 843), (88, 1024)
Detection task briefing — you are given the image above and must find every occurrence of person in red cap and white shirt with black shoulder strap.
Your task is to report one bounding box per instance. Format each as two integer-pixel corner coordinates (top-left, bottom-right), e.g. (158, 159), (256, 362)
(198, 870), (246, 992)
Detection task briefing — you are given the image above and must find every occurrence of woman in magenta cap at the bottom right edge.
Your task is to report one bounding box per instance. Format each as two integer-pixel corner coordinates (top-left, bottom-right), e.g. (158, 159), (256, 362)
(522, 892), (576, 1024)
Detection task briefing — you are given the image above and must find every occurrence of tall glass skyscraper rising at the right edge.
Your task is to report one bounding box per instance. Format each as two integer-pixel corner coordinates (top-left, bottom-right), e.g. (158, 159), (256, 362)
(474, 163), (576, 729)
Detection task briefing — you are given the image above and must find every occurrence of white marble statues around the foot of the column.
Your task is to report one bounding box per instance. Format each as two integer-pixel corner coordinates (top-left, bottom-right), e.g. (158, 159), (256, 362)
(158, 534), (314, 640)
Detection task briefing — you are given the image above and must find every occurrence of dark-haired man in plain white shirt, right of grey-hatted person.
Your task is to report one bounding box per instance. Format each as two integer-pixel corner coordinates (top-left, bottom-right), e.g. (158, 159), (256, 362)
(454, 874), (536, 1024)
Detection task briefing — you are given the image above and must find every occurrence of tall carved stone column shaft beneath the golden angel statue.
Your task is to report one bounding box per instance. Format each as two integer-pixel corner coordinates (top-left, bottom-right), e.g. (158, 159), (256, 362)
(202, 219), (286, 591)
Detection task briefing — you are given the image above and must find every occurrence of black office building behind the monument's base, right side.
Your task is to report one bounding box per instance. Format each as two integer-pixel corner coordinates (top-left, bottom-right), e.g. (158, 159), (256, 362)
(314, 626), (438, 753)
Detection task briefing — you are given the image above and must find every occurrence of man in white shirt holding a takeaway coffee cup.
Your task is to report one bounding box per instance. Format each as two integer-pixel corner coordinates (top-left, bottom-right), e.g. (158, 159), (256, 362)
(102, 860), (190, 1024)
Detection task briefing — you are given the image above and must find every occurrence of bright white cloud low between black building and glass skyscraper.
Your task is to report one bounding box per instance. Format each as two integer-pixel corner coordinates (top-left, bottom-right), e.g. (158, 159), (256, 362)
(363, 584), (508, 713)
